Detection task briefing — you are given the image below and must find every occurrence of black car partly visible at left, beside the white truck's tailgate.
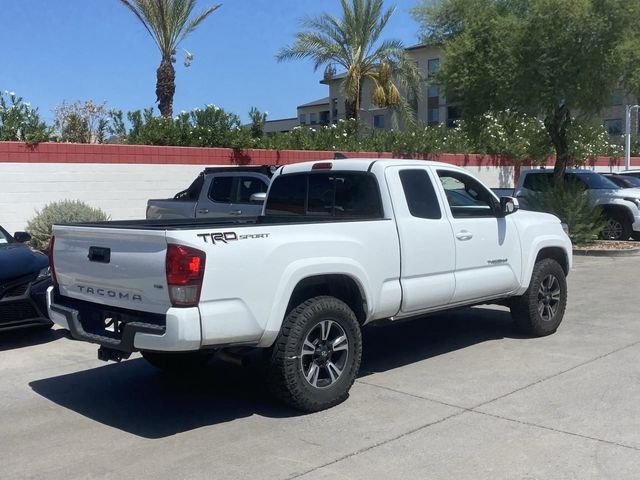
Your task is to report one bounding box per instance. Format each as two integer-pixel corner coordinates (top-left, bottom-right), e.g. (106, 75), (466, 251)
(0, 227), (52, 330)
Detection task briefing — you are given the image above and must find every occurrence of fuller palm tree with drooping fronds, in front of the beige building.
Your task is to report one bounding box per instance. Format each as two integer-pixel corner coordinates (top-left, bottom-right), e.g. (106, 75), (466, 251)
(276, 0), (420, 122)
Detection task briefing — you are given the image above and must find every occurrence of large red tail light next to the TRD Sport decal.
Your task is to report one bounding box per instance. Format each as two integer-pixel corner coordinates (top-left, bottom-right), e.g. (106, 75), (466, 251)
(166, 244), (206, 307)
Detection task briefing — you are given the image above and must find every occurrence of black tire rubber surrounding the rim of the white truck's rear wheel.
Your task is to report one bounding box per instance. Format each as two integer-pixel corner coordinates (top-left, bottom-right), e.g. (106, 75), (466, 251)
(268, 296), (362, 412)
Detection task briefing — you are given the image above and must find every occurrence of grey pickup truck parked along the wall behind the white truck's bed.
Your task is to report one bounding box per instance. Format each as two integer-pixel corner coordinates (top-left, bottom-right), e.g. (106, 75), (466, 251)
(147, 166), (276, 220)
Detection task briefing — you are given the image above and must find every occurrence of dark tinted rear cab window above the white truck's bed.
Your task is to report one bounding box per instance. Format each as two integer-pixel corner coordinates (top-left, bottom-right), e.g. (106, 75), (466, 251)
(265, 171), (383, 219)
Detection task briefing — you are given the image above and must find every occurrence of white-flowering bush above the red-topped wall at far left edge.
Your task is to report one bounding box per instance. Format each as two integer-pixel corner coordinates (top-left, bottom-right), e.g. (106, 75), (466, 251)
(0, 90), (50, 144)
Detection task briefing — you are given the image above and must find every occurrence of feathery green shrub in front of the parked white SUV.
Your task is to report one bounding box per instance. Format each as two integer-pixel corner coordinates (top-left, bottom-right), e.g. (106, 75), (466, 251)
(525, 181), (606, 244)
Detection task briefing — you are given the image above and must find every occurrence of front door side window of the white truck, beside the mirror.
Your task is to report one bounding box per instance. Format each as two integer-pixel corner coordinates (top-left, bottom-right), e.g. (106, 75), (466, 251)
(438, 170), (497, 218)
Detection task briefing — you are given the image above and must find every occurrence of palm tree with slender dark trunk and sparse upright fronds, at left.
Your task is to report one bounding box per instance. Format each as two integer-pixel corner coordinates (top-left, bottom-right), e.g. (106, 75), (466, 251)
(120, 0), (221, 117)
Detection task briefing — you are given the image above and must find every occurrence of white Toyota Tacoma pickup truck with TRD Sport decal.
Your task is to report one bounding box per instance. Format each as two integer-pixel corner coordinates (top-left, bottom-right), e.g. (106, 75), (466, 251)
(48, 160), (572, 411)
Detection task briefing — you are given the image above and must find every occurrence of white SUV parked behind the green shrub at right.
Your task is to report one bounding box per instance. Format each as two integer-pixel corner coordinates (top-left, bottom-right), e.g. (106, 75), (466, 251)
(515, 169), (640, 240)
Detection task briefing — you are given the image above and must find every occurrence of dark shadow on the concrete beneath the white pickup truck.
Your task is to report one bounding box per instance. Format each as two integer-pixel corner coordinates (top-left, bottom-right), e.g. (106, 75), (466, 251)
(30, 308), (517, 439)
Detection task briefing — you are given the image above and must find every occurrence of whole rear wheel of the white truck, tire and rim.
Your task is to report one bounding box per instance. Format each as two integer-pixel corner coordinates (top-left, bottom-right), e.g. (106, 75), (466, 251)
(269, 296), (362, 412)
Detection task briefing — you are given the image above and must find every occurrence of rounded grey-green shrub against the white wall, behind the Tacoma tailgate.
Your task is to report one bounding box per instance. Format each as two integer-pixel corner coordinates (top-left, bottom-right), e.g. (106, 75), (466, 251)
(27, 200), (109, 253)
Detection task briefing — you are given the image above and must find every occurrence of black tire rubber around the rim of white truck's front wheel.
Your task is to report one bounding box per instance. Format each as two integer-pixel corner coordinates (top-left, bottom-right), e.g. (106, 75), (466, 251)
(511, 258), (567, 337)
